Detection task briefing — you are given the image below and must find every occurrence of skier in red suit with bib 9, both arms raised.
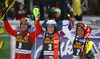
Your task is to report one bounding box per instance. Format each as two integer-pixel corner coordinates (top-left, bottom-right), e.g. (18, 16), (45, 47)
(4, 17), (41, 59)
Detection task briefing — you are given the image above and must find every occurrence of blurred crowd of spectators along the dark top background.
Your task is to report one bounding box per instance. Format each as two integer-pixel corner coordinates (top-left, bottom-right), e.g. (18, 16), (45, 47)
(0, 0), (100, 22)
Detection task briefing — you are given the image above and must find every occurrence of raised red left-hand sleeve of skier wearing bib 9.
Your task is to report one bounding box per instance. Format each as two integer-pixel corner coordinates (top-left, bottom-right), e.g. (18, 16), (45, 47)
(4, 20), (18, 37)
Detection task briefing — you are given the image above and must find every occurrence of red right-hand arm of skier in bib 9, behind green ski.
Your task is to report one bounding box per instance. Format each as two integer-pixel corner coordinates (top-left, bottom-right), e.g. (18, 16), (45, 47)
(30, 20), (41, 43)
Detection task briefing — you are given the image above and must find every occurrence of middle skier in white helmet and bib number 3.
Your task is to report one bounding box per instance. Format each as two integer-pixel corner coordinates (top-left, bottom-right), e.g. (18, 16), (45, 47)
(39, 20), (65, 59)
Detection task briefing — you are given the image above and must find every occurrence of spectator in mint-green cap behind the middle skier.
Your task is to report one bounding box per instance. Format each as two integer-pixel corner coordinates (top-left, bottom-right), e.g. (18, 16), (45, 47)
(42, 8), (62, 31)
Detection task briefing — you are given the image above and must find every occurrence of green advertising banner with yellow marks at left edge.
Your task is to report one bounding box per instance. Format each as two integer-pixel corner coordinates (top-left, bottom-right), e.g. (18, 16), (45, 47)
(0, 27), (9, 59)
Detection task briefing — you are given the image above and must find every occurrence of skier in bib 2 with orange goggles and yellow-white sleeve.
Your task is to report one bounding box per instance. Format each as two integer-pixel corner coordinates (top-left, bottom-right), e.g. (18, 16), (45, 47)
(71, 23), (99, 59)
